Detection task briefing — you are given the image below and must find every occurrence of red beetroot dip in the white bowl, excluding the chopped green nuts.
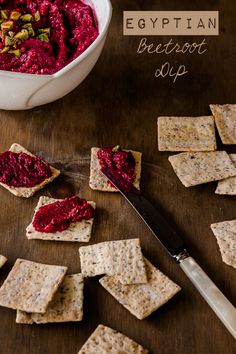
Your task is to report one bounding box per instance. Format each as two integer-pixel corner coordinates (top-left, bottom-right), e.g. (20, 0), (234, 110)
(0, 0), (98, 74)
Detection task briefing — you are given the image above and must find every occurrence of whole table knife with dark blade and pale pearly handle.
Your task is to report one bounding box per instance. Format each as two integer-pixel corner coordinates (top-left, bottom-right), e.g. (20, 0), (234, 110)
(102, 169), (236, 339)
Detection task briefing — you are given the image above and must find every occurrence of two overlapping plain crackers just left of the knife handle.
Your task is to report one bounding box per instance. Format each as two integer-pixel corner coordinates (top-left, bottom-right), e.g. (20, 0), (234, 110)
(79, 239), (180, 320)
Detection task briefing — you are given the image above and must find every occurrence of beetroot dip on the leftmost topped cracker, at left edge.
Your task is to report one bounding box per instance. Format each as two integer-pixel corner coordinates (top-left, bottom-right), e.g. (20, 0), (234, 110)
(0, 151), (52, 188)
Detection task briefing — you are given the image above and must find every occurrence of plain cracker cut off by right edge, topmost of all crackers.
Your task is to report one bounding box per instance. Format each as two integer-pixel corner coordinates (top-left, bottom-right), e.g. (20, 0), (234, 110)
(210, 104), (236, 144)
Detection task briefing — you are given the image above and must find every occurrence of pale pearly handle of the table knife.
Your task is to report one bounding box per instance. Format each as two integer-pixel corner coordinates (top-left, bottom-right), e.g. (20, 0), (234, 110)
(179, 257), (236, 339)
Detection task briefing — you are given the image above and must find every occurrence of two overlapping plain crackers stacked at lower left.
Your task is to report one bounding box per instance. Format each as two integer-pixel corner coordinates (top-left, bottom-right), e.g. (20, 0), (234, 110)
(0, 259), (84, 324)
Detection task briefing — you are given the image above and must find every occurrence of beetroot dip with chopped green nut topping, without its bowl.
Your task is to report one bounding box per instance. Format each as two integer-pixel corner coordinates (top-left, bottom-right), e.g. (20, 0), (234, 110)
(0, 0), (98, 74)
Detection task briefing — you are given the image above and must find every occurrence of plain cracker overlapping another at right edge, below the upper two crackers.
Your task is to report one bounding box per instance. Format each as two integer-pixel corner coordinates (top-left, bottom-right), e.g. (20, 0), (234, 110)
(169, 151), (236, 187)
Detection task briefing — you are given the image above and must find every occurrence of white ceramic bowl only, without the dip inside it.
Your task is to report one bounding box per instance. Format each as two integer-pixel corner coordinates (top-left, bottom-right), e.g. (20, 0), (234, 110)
(0, 0), (112, 110)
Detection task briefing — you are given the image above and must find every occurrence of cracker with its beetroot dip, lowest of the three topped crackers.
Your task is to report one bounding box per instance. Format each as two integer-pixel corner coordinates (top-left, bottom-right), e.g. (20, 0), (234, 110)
(26, 196), (96, 242)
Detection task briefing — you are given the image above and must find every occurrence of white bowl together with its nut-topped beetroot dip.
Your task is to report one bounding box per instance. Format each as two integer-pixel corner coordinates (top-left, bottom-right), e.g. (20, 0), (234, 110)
(0, 0), (112, 110)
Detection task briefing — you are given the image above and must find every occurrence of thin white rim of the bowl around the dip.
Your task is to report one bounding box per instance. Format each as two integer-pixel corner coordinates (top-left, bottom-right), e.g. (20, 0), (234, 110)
(0, 0), (112, 80)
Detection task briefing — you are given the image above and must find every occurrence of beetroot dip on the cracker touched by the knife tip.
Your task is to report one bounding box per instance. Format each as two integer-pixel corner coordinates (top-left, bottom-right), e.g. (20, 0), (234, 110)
(97, 147), (139, 193)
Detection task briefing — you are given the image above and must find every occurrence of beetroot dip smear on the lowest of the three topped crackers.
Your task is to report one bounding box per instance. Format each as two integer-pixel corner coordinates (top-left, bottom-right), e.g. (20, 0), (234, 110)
(33, 196), (94, 233)
